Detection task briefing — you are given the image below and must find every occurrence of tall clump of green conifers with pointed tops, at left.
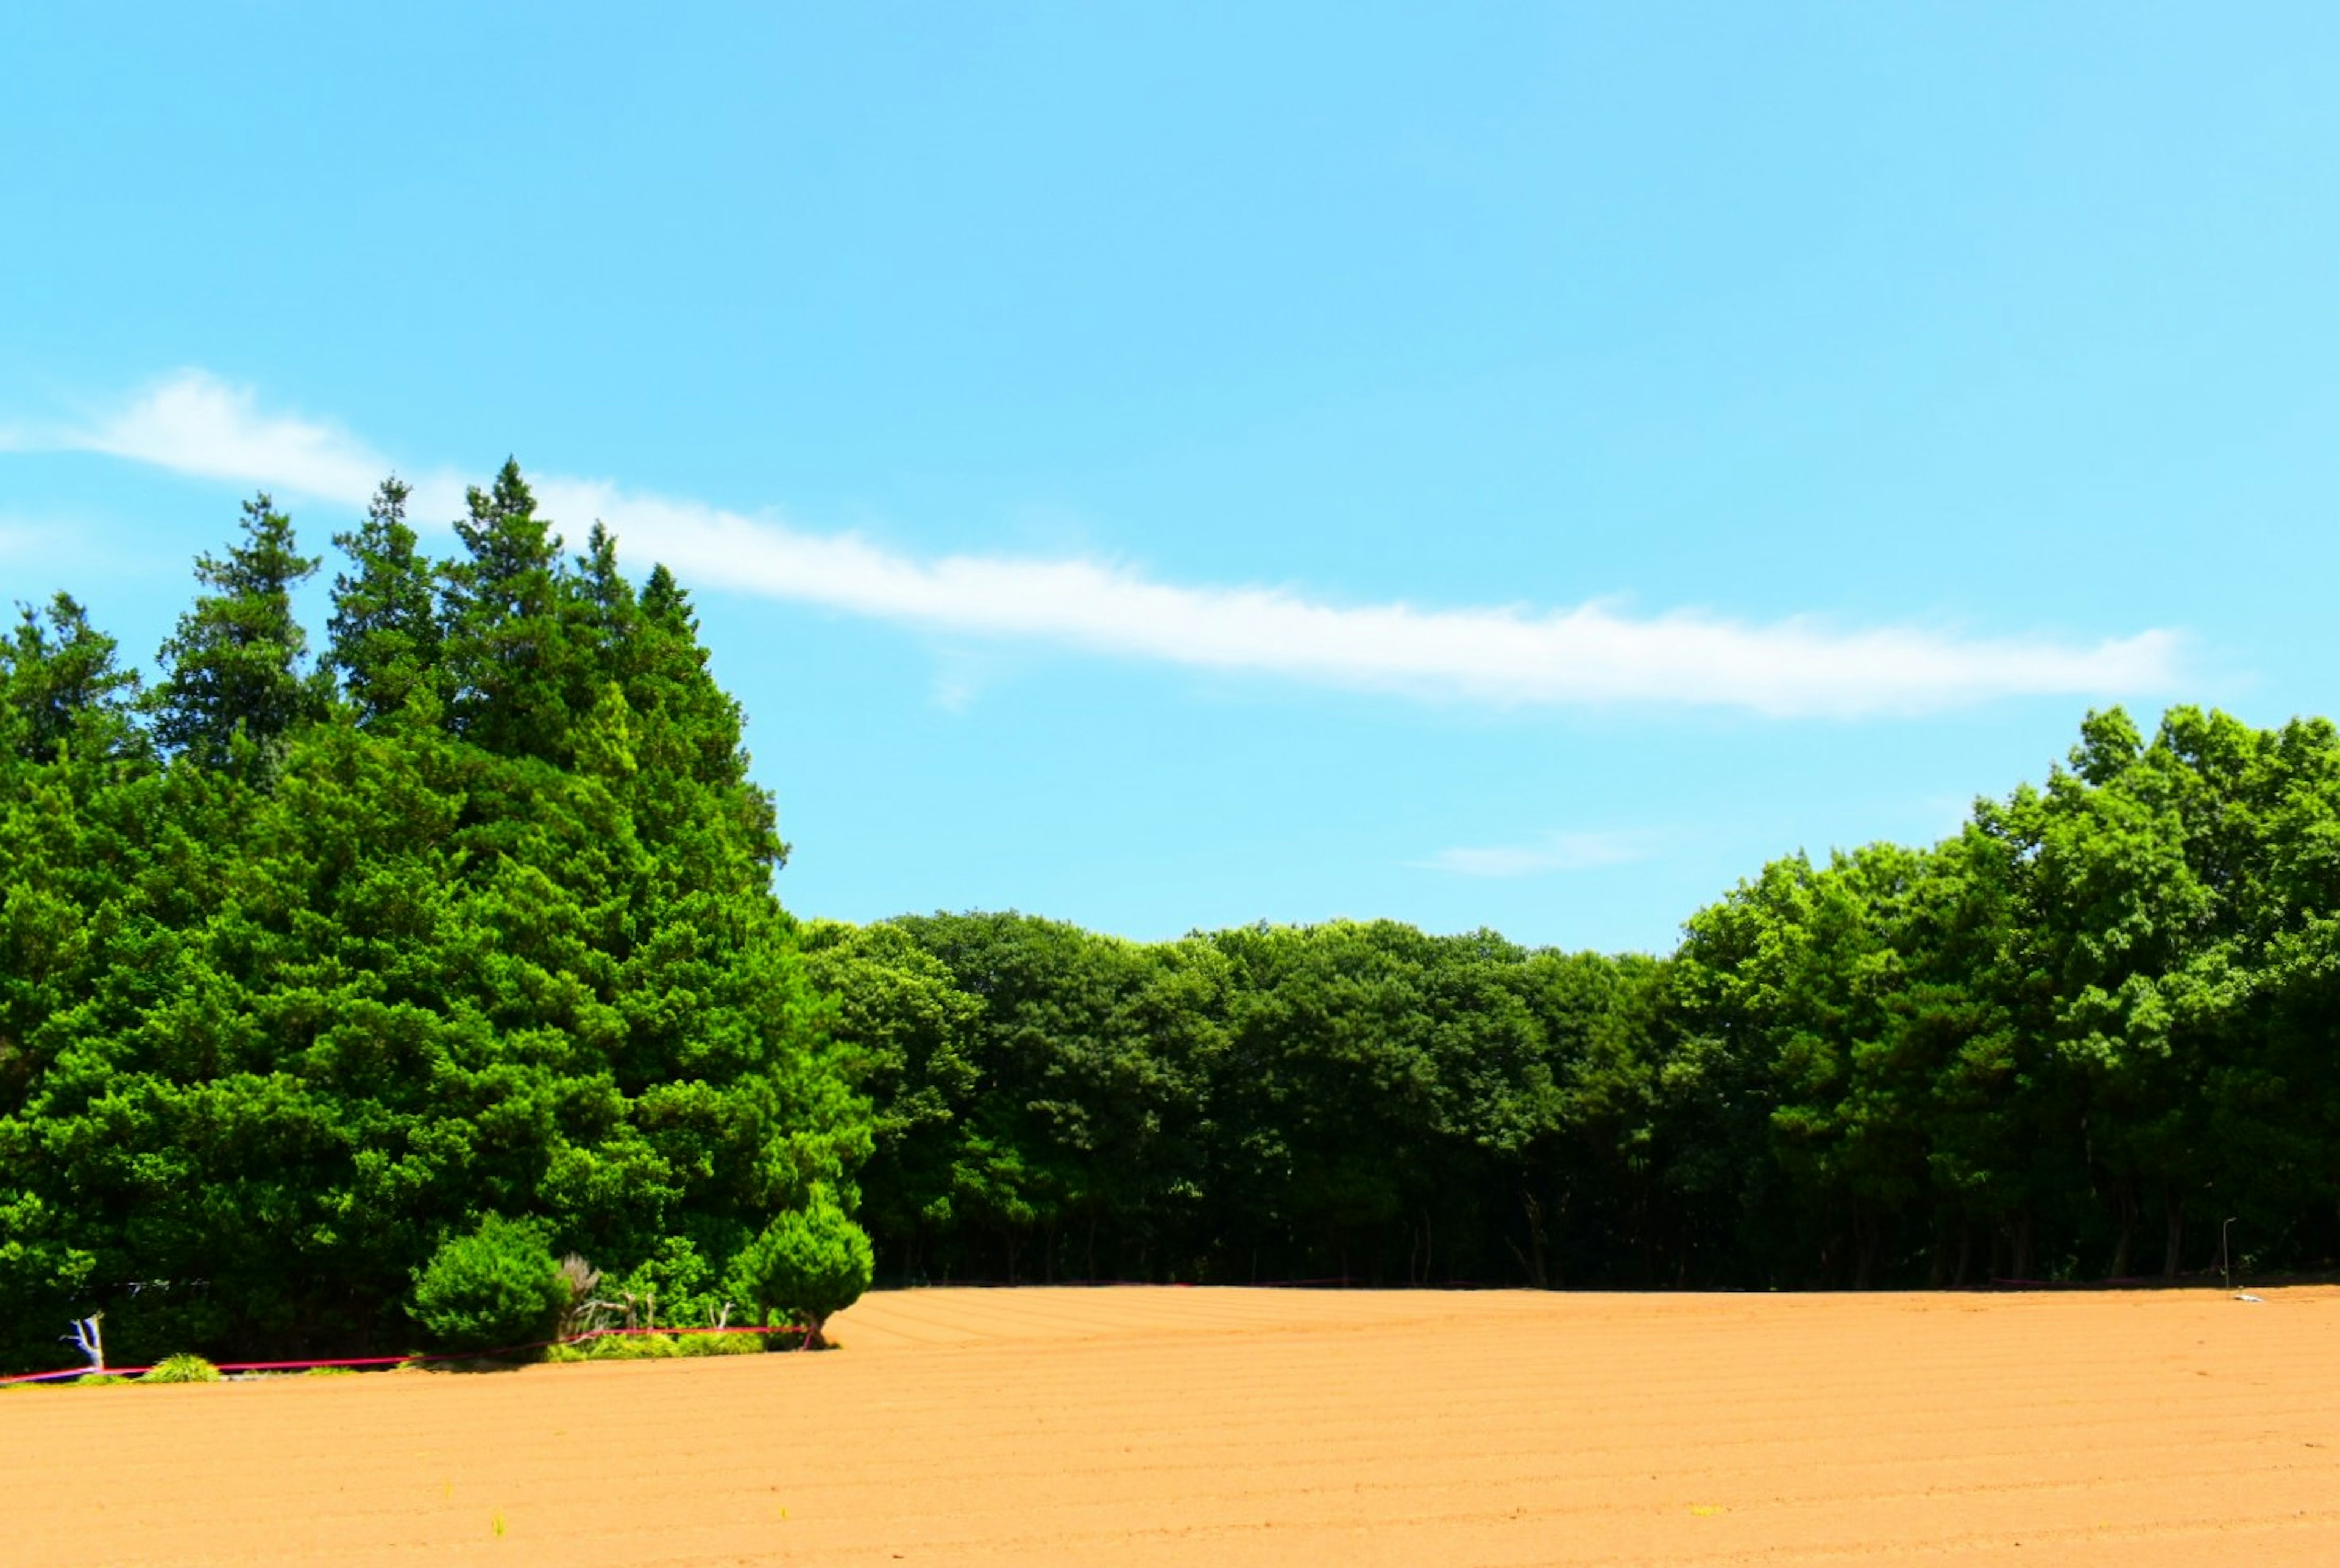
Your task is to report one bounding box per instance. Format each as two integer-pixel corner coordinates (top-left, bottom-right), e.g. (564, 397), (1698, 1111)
(0, 468), (870, 1367)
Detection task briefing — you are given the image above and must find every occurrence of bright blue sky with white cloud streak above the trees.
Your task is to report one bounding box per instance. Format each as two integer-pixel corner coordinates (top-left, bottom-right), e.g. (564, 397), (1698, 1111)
(0, 2), (2340, 948)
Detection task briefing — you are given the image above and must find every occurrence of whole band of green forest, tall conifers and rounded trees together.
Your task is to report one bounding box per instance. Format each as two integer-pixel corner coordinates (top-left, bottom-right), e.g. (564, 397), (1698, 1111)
(0, 466), (2340, 1367)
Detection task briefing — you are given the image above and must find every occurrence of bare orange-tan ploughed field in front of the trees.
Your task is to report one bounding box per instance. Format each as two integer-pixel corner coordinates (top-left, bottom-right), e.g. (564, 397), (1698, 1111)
(0, 1290), (2340, 1568)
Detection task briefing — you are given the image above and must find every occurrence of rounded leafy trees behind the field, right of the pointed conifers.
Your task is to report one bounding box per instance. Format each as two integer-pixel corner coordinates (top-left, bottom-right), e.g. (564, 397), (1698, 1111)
(805, 707), (2340, 1287)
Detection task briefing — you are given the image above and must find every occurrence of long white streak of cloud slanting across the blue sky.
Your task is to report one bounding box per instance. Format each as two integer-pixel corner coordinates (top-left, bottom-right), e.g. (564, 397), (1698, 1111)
(16, 372), (2179, 720)
